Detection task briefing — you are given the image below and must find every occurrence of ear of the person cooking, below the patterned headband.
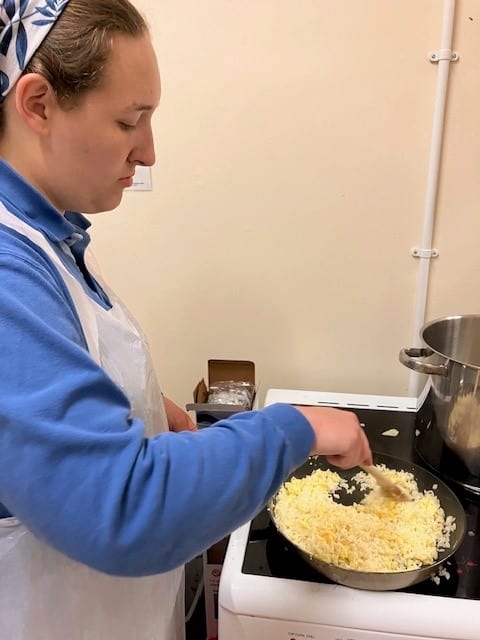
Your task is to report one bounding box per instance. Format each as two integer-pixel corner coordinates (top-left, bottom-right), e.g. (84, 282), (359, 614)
(15, 73), (57, 135)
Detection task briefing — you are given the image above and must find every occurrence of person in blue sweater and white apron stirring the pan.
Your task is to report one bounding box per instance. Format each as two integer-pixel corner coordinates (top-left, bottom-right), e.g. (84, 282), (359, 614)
(0, 0), (372, 640)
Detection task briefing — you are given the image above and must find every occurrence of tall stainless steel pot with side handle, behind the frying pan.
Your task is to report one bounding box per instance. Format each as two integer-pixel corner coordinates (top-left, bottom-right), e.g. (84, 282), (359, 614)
(399, 315), (480, 476)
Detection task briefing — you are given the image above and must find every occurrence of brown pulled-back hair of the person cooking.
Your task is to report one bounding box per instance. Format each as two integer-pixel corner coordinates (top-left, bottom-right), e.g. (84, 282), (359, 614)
(0, 0), (148, 134)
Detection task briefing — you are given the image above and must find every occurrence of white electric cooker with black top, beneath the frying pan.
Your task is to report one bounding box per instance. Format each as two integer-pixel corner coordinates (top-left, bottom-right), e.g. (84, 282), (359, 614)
(219, 389), (480, 640)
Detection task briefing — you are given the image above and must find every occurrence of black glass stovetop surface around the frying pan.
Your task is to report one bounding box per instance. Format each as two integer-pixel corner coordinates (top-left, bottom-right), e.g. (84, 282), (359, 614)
(242, 397), (480, 600)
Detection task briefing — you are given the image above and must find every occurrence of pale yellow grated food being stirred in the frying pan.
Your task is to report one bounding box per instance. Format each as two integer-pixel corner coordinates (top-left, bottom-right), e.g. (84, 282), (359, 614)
(274, 465), (455, 572)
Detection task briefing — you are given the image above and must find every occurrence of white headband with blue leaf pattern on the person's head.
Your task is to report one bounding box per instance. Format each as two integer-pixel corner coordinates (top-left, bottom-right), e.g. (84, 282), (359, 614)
(0, 0), (68, 102)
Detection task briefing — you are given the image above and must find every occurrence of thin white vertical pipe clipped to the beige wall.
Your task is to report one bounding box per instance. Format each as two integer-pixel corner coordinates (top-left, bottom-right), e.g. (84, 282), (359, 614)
(408, 0), (455, 397)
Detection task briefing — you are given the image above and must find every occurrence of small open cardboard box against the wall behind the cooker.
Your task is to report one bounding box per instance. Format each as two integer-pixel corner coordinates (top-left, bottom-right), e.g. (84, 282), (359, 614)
(186, 360), (256, 426)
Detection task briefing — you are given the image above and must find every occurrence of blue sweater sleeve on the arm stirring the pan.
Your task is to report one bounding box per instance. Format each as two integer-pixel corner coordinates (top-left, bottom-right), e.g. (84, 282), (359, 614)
(0, 238), (313, 576)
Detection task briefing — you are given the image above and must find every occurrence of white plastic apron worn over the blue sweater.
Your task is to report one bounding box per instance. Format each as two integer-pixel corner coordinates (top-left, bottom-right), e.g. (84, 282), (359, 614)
(0, 203), (184, 640)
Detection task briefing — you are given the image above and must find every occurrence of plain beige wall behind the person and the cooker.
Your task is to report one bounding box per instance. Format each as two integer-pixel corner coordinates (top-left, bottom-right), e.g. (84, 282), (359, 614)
(88, 0), (480, 404)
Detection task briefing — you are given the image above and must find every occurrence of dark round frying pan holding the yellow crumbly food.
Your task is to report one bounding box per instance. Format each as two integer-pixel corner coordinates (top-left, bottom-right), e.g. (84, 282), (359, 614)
(268, 453), (466, 591)
